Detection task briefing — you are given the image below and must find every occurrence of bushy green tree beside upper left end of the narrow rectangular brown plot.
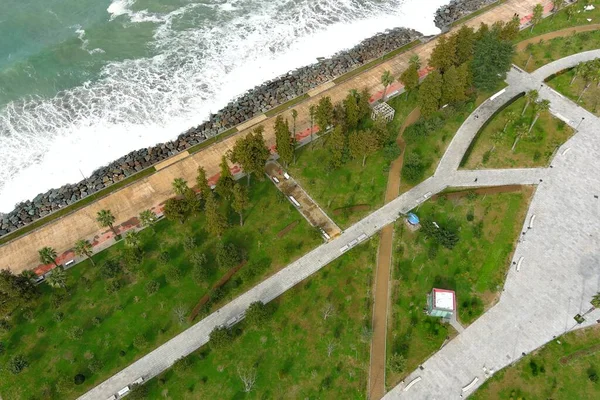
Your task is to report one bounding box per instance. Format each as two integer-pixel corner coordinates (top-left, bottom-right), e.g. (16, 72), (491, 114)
(231, 125), (270, 184)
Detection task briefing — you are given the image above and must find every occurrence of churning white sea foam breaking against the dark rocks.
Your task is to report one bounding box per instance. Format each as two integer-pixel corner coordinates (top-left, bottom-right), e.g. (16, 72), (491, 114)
(0, 0), (448, 212)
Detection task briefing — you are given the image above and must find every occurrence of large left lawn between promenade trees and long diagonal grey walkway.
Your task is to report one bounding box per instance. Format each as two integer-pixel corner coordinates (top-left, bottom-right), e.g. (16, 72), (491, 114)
(0, 181), (321, 399)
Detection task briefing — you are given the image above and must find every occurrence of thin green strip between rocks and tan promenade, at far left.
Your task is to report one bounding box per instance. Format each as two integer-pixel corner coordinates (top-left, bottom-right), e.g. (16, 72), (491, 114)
(0, 167), (156, 245)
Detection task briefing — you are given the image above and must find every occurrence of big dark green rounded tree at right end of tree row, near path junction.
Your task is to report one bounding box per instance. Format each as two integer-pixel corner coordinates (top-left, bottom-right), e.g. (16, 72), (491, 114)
(471, 31), (514, 90)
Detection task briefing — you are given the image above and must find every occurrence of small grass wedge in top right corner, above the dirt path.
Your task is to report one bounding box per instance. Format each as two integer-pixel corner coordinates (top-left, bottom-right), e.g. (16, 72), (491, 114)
(515, 0), (600, 42)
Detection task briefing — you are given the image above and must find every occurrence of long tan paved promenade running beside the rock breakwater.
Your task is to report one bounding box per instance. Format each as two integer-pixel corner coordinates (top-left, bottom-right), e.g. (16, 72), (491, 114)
(0, 0), (550, 272)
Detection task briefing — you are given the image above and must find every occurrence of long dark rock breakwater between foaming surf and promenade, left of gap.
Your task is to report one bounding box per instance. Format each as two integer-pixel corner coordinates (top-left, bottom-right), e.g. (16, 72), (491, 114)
(0, 28), (422, 241)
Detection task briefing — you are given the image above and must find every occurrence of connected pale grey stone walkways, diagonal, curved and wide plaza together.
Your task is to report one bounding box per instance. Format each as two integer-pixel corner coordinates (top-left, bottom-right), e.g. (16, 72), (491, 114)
(80, 50), (600, 399)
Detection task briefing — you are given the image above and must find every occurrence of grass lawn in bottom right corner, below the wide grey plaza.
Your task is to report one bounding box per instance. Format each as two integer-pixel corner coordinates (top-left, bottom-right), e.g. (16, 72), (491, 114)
(472, 326), (600, 400)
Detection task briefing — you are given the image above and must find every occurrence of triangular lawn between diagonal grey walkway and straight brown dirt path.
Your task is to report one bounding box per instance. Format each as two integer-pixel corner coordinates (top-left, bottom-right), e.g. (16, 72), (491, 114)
(147, 239), (378, 399)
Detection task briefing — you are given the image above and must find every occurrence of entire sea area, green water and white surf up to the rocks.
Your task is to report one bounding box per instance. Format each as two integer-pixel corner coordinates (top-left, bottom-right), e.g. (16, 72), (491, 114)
(0, 0), (449, 212)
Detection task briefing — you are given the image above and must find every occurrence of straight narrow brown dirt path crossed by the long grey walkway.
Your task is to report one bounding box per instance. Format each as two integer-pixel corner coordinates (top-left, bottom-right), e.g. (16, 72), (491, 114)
(369, 108), (421, 400)
